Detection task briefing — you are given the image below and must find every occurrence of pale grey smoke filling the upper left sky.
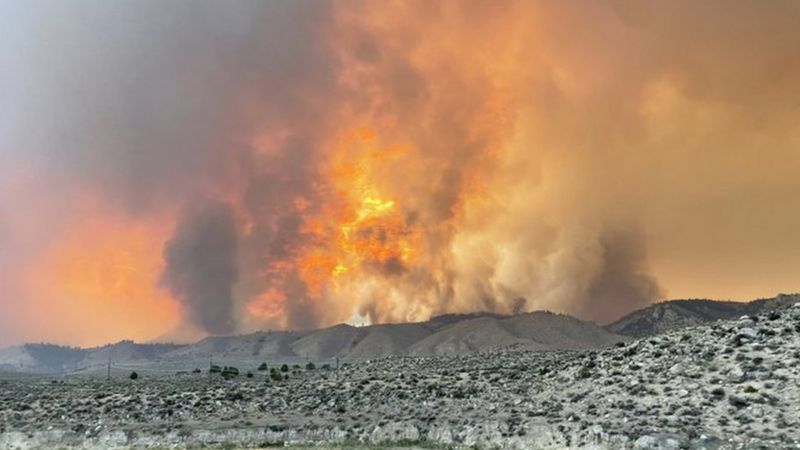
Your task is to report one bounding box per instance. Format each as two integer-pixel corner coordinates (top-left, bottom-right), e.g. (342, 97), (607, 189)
(0, 0), (335, 214)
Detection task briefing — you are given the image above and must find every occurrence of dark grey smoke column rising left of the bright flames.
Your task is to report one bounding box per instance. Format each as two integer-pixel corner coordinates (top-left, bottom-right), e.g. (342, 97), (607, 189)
(161, 202), (238, 334)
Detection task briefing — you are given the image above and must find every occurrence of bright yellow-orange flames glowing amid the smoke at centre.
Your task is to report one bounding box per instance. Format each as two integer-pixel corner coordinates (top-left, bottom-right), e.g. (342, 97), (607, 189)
(255, 128), (422, 317)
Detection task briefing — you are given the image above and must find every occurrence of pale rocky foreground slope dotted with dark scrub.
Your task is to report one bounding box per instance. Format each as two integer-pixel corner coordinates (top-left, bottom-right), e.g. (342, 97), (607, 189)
(0, 305), (800, 450)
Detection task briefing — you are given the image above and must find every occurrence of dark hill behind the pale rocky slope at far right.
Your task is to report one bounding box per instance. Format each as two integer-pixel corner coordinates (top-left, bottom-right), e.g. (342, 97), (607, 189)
(606, 294), (800, 337)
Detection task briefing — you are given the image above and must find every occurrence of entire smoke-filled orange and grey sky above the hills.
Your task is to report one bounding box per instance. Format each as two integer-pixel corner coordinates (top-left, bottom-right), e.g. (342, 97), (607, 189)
(0, 0), (800, 345)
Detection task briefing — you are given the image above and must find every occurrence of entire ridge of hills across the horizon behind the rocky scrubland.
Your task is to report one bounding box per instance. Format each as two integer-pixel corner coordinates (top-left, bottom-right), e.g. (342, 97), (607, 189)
(0, 294), (800, 373)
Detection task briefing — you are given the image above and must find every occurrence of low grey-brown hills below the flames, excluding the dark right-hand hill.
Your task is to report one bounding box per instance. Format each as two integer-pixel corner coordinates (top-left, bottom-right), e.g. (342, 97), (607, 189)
(0, 312), (625, 373)
